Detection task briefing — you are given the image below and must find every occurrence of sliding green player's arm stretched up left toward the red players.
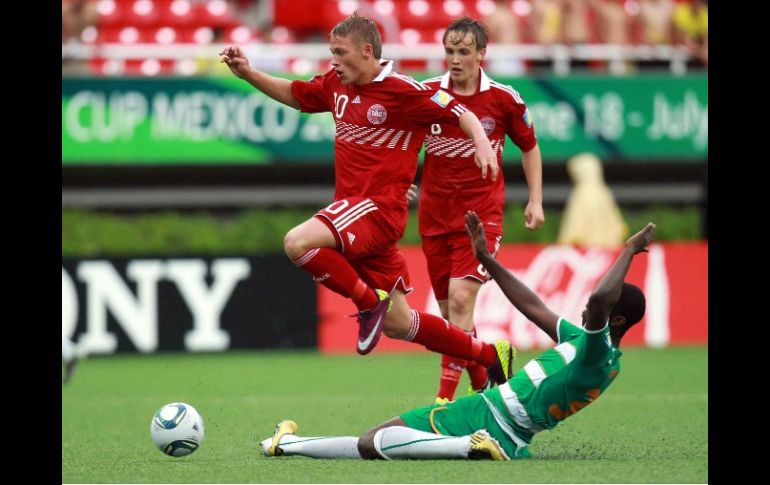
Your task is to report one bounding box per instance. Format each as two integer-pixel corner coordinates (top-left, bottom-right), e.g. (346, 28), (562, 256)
(465, 211), (559, 342)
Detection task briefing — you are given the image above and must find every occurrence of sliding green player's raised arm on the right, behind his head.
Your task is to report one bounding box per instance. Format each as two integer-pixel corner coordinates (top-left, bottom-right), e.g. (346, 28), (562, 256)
(585, 222), (655, 330)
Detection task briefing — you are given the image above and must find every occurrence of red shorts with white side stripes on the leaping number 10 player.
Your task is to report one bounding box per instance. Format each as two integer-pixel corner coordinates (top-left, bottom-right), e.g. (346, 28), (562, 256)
(315, 197), (412, 293)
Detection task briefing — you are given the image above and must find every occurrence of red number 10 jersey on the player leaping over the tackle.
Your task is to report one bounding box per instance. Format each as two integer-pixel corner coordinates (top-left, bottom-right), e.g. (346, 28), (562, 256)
(291, 60), (464, 233)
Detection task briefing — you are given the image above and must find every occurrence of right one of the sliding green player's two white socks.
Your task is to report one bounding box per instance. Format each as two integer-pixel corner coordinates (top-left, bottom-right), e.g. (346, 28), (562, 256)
(372, 426), (471, 460)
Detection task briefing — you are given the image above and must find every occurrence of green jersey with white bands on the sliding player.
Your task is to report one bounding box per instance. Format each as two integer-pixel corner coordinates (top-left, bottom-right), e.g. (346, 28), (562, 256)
(483, 318), (621, 446)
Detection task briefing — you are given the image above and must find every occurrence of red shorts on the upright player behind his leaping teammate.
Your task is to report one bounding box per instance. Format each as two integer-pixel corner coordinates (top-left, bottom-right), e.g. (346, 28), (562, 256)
(422, 228), (503, 301)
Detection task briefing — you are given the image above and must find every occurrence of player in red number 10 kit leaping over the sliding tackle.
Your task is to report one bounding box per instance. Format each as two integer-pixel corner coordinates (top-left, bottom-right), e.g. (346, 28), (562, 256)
(221, 13), (513, 383)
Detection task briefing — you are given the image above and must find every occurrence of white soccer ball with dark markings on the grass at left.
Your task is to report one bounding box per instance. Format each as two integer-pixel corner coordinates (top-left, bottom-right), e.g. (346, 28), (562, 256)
(150, 402), (203, 456)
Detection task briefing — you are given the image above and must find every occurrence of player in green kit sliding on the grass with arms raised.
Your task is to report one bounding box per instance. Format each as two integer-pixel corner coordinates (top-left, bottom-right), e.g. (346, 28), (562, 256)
(261, 211), (655, 460)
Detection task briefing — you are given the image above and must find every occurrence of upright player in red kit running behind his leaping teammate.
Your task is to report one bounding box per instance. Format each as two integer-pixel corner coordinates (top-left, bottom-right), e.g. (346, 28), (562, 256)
(418, 17), (544, 403)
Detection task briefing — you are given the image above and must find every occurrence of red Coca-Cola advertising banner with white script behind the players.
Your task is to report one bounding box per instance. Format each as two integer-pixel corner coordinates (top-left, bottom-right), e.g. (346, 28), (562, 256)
(318, 242), (708, 353)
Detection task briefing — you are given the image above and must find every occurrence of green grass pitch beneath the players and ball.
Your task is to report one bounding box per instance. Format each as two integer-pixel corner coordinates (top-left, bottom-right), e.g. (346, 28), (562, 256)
(62, 344), (708, 483)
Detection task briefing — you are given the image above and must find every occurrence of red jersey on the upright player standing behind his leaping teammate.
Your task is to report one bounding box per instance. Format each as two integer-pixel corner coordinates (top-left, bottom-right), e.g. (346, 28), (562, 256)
(418, 69), (537, 236)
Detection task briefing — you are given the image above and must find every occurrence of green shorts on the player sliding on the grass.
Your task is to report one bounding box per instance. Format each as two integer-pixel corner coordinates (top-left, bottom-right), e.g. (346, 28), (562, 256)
(400, 394), (530, 458)
